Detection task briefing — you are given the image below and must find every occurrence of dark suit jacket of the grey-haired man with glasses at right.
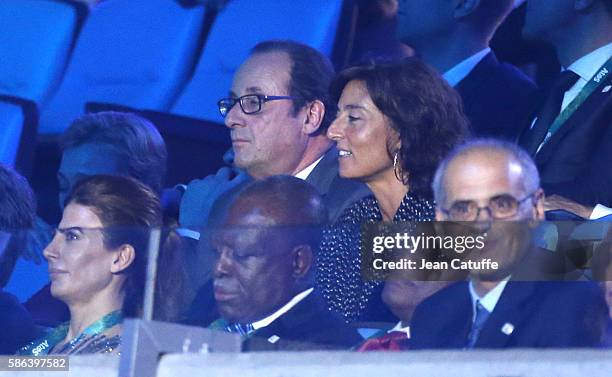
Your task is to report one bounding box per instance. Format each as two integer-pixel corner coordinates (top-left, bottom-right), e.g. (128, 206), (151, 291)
(410, 280), (607, 349)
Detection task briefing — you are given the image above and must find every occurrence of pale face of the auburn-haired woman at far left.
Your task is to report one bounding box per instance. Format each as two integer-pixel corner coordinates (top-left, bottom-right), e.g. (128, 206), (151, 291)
(43, 202), (115, 303)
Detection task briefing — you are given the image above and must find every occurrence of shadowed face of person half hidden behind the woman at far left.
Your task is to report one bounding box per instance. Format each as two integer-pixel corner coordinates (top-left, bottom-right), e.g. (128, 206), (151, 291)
(57, 143), (126, 209)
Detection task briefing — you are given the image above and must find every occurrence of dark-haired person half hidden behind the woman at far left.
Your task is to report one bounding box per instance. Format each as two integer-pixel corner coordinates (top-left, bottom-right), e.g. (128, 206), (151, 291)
(17, 112), (168, 326)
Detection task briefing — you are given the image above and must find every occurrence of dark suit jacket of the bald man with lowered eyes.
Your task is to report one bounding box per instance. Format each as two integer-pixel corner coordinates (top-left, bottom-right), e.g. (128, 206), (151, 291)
(243, 291), (363, 351)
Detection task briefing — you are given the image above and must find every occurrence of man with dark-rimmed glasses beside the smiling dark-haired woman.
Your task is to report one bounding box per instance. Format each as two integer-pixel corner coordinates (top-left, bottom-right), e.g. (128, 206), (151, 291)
(179, 41), (369, 324)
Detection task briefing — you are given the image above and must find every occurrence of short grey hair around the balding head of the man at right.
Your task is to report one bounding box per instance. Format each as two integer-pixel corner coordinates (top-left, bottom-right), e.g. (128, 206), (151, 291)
(432, 138), (540, 205)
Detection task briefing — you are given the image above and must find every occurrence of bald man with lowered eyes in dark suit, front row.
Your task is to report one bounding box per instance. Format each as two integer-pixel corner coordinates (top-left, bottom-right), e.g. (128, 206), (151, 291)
(211, 176), (361, 351)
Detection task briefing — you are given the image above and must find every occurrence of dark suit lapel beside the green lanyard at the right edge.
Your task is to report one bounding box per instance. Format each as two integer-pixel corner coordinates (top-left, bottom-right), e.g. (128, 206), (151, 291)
(536, 75), (612, 165)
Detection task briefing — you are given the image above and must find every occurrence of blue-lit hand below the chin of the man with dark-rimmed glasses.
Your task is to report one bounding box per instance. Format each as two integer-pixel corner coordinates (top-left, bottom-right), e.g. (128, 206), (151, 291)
(179, 167), (250, 231)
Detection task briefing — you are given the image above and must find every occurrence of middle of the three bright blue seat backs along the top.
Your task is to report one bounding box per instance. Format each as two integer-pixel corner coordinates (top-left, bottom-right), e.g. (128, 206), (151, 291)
(40, 0), (205, 135)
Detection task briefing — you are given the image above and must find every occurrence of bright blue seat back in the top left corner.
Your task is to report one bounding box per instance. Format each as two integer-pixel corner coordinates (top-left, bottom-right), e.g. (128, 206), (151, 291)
(0, 0), (87, 104)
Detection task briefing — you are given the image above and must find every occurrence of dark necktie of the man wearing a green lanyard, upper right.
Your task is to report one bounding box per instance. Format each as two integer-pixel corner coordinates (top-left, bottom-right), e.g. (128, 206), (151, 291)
(521, 70), (580, 156)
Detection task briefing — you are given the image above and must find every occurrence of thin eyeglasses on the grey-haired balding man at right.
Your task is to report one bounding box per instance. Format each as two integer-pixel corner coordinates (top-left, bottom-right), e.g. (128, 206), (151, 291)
(441, 192), (536, 221)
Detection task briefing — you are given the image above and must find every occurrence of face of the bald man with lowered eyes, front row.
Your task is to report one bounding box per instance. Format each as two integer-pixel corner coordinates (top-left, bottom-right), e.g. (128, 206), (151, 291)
(212, 199), (310, 323)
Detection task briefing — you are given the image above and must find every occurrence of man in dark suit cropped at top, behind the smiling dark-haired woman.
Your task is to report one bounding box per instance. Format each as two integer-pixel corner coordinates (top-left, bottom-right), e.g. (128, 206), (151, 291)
(397, 0), (536, 140)
